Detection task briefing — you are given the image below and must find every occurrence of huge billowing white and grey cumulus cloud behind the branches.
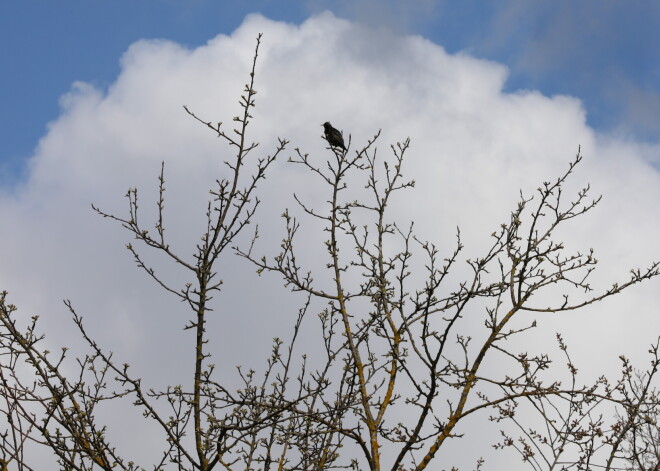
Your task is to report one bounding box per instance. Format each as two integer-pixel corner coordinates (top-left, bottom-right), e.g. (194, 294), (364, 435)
(0, 13), (660, 471)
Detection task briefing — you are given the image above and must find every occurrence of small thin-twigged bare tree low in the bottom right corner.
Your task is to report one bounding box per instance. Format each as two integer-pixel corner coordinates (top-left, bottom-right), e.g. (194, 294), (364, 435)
(491, 337), (660, 470)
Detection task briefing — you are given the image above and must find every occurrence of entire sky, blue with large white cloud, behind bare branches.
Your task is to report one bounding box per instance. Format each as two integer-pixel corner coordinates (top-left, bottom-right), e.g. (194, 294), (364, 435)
(0, 0), (660, 469)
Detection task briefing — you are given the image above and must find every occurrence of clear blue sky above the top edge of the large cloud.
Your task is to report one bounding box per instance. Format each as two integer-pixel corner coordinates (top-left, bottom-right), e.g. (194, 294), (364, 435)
(0, 0), (660, 185)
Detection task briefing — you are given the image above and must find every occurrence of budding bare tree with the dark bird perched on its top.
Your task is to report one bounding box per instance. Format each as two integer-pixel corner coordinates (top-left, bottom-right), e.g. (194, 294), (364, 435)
(240, 127), (659, 470)
